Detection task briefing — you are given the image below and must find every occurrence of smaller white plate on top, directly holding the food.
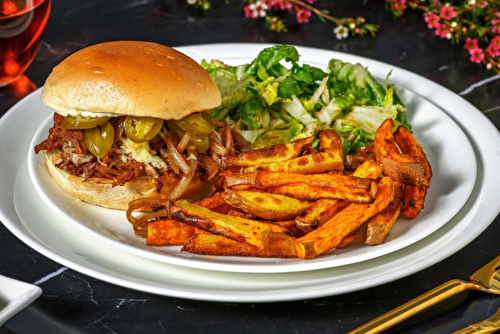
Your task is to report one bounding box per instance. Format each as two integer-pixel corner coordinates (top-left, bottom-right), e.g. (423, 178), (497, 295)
(28, 70), (477, 273)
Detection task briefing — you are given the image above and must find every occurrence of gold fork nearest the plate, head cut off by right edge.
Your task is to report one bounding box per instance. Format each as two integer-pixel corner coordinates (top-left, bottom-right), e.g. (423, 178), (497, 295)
(347, 256), (500, 334)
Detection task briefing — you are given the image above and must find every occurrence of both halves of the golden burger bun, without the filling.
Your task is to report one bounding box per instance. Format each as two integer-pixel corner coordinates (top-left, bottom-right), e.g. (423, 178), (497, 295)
(41, 41), (221, 210)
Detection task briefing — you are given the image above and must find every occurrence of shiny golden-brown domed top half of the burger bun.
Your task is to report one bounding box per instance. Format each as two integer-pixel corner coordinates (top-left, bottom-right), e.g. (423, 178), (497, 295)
(42, 41), (221, 120)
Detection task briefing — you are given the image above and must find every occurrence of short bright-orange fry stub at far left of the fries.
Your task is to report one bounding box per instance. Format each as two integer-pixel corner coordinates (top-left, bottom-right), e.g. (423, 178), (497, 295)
(146, 219), (207, 246)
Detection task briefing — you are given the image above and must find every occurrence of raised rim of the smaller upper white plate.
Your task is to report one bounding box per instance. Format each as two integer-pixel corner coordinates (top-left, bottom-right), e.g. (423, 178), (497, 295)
(28, 82), (477, 273)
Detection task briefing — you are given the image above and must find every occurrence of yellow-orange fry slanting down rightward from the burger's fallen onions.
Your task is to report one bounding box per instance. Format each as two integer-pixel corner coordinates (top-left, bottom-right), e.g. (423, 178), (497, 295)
(168, 200), (271, 249)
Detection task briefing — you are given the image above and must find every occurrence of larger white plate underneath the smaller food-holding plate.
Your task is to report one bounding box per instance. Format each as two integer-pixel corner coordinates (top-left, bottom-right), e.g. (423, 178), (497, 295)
(0, 44), (500, 302)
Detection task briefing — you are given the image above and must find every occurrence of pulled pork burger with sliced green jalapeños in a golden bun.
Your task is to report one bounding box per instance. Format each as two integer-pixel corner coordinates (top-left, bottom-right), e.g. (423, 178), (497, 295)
(34, 41), (226, 210)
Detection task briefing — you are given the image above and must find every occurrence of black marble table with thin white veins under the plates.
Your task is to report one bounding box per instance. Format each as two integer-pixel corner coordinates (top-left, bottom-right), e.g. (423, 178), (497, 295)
(0, 0), (500, 334)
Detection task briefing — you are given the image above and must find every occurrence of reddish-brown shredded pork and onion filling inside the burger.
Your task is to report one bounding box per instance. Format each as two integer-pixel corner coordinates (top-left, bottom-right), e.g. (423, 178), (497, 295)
(35, 113), (250, 199)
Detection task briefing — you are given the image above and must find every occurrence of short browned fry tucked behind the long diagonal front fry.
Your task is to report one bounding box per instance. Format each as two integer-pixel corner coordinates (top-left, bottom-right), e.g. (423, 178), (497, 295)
(295, 199), (351, 233)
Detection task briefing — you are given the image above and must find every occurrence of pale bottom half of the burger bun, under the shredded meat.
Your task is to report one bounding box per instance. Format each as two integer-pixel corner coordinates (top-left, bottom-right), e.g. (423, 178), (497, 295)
(45, 150), (210, 210)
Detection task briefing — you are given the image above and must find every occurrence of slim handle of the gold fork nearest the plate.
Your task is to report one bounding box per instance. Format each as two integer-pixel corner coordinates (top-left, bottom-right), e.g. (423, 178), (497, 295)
(347, 279), (476, 334)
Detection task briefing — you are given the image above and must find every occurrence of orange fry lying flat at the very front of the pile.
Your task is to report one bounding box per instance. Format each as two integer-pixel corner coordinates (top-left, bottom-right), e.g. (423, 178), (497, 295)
(182, 233), (297, 258)
